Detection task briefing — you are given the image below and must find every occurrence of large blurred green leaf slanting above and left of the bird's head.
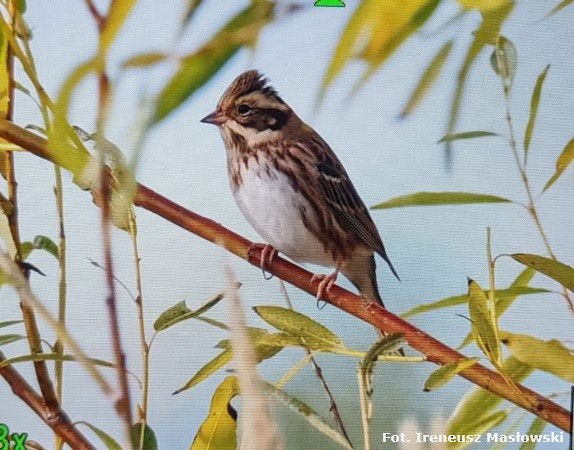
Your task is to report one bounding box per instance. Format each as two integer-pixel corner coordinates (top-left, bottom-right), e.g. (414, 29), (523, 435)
(153, 0), (274, 123)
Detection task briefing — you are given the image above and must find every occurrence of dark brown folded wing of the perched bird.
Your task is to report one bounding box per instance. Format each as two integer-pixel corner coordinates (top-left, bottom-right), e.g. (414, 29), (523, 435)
(315, 148), (399, 278)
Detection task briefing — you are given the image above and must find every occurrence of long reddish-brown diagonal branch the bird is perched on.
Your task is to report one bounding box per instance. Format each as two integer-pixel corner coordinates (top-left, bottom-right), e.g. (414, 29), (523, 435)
(0, 120), (571, 432)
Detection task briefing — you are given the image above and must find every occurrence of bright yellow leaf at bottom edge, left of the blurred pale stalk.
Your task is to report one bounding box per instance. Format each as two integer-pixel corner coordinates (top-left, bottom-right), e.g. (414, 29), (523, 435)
(189, 376), (239, 450)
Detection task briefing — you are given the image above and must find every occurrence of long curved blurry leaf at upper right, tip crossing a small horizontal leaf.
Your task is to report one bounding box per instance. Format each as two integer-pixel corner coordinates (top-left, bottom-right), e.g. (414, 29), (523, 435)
(445, 0), (514, 167)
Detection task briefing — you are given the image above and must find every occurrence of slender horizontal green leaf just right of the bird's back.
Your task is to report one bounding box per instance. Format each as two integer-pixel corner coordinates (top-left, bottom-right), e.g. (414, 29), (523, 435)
(371, 192), (512, 209)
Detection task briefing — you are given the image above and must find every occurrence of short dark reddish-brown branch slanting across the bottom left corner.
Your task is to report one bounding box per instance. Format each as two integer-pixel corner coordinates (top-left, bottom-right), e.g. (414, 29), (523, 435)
(0, 352), (95, 450)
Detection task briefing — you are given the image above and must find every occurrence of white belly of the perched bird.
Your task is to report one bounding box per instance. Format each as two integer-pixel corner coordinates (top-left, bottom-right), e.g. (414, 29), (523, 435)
(233, 160), (334, 266)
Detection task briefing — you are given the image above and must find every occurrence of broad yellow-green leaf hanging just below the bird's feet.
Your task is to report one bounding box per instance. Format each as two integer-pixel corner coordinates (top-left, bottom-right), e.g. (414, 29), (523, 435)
(253, 306), (344, 351)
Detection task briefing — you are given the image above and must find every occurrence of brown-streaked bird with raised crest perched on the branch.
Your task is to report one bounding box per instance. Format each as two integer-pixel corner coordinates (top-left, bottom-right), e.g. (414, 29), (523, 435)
(201, 70), (400, 307)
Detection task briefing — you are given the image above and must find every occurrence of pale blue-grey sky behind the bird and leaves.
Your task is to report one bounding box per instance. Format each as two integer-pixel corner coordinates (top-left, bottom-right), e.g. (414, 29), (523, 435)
(0, 0), (574, 449)
